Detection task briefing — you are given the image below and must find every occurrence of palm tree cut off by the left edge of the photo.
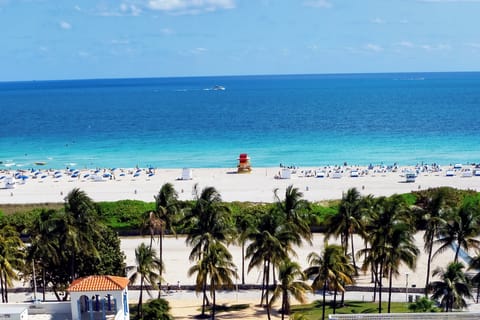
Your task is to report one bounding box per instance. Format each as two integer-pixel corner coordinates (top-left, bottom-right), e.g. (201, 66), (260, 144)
(0, 225), (24, 303)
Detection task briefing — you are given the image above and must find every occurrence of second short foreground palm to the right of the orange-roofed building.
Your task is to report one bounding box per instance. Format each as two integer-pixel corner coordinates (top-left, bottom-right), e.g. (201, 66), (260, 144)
(188, 240), (237, 319)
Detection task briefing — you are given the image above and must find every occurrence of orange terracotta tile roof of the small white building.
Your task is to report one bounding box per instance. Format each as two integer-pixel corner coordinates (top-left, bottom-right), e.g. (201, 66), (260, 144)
(68, 276), (129, 292)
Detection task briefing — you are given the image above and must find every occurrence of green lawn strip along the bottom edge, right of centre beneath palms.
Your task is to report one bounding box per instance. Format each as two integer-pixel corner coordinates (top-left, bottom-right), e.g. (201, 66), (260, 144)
(292, 300), (410, 320)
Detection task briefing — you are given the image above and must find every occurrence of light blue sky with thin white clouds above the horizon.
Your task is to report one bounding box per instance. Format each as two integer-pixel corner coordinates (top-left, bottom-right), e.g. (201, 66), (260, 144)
(0, 0), (480, 81)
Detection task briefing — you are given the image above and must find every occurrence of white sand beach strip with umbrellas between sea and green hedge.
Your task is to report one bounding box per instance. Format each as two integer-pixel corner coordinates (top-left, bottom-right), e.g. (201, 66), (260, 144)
(0, 165), (480, 204)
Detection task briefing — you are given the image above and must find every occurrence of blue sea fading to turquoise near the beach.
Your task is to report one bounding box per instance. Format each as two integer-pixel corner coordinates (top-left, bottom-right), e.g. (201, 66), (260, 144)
(0, 73), (480, 169)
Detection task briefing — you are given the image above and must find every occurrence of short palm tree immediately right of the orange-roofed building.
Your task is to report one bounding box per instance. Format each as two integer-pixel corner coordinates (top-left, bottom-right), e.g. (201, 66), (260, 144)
(127, 243), (161, 317)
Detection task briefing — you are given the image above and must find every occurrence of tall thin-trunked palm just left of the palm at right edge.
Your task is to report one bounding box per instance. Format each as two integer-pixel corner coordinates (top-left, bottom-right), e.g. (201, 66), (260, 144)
(419, 188), (451, 296)
